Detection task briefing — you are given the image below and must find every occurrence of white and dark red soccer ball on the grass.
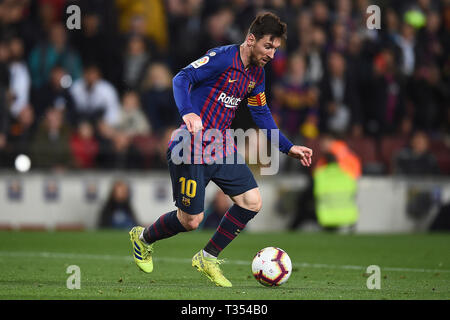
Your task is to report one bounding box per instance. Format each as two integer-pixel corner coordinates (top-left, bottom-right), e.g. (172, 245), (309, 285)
(252, 247), (292, 287)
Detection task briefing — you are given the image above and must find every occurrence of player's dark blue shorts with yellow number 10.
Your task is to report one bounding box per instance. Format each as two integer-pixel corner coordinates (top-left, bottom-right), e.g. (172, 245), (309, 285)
(167, 150), (258, 215)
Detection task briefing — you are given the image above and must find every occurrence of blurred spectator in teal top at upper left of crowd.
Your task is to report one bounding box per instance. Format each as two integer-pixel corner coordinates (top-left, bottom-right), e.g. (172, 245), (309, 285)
(29, 23), (82, 89)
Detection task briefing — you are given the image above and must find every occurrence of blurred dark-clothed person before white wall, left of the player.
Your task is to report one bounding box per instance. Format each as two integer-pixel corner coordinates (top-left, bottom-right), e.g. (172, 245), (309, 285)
(98, 180), (137, 229)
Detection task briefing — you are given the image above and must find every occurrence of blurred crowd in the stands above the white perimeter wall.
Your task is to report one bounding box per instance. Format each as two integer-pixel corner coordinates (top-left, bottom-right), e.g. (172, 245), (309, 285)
(0, 0), (450, 174)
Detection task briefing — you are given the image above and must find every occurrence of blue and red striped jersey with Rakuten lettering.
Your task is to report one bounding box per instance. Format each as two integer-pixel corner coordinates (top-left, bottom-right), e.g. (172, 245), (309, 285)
(169, 44), (292, 162)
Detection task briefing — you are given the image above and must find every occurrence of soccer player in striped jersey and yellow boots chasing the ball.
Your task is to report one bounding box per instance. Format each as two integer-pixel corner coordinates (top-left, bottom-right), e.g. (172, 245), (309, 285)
(129, 12), (312, 287)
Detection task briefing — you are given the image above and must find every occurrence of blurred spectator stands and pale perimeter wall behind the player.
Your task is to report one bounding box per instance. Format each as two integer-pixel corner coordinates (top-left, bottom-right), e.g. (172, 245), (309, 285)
(0, 0), (450, 232)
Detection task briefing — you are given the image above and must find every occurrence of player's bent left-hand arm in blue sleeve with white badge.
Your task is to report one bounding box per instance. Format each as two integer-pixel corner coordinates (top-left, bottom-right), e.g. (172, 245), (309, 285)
(173, 51), (226, 133)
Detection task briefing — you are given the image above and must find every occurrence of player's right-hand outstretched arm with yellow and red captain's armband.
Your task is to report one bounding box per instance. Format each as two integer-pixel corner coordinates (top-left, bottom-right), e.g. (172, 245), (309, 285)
(248, 81), (313, 167)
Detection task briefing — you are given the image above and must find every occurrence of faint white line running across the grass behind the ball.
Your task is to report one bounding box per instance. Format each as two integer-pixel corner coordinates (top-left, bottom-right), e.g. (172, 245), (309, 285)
(0, 251), (450, 273)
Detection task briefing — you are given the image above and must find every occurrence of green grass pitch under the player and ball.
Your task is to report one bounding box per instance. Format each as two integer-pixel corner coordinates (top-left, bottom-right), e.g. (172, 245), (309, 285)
(0, 231), (450, 300)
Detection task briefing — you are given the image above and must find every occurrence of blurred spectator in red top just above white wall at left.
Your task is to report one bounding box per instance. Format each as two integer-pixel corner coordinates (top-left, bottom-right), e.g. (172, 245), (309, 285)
(70, 121), (99, 169)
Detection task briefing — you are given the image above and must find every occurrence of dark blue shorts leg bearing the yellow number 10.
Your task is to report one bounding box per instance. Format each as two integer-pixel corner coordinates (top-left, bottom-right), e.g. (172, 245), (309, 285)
(168, 155), (207, 215)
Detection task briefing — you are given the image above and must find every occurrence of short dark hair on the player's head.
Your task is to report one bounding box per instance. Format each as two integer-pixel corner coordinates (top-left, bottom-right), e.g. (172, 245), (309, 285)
(248, 12), (287, 41)
